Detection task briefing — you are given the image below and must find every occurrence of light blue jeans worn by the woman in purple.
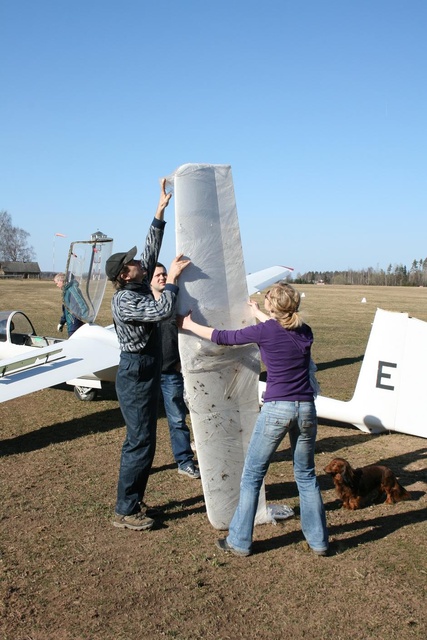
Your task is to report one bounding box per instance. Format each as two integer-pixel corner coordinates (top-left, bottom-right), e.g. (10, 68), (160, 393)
(227, 401), (328, 551)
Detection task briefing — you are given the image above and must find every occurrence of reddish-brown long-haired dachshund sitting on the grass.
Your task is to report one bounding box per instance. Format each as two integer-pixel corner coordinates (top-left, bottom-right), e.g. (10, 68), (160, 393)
(324, 458), (411, 509)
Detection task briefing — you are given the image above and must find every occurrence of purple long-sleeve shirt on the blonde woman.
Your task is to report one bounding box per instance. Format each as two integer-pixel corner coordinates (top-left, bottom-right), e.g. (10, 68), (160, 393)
(211, 320), (314, 402)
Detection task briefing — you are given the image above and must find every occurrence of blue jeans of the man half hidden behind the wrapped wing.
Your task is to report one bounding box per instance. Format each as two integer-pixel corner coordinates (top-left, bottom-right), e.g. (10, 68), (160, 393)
(161, 371), (194, 467)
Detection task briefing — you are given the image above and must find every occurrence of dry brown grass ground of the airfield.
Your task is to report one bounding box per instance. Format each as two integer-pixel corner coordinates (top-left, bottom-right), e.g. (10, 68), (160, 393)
(0, 281), (427, 640)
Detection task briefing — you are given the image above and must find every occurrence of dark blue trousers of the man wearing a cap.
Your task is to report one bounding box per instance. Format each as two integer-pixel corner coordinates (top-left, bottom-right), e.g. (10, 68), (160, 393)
(116, 349), (161, 515)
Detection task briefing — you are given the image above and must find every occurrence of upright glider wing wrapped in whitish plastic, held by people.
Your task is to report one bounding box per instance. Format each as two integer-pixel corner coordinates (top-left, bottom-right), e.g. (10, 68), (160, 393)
(168, 164), (271, 529)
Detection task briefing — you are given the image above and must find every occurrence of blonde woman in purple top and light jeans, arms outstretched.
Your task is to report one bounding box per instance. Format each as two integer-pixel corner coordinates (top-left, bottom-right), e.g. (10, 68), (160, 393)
(181, 284), (328, 556)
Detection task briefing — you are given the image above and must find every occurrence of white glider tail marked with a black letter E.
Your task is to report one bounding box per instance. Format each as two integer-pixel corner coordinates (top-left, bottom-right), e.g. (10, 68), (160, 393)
(316, 309), (427, 438)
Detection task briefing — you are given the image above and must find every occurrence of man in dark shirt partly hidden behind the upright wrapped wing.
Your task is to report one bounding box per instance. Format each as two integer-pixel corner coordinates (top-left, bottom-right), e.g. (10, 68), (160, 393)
(151, 262), (200, 479)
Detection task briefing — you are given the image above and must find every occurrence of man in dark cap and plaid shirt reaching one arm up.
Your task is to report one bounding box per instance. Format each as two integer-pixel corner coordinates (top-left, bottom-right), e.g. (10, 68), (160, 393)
(106, 179), (190, 531)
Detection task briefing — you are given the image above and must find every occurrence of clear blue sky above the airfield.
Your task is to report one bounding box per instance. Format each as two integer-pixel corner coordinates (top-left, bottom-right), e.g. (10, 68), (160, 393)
(0, 0), (427, 273)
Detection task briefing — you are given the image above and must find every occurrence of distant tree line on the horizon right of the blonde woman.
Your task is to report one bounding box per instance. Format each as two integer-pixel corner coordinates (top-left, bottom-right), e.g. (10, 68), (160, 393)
(293, 258), (427, 287)
